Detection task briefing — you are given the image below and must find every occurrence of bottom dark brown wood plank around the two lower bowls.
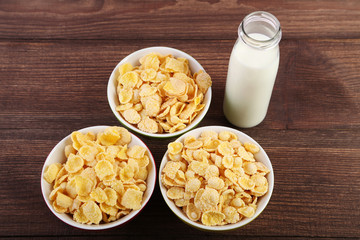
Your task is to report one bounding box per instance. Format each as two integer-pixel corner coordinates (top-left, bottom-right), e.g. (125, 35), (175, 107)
(0, 128), (360, 239)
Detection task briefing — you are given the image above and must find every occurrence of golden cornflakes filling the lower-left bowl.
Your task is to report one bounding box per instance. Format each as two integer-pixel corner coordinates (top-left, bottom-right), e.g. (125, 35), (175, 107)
(44, 127), (150, 224)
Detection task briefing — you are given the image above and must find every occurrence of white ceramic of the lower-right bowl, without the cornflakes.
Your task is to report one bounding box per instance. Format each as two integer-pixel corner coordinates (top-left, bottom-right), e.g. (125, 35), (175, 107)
(159, 126), (274, 231)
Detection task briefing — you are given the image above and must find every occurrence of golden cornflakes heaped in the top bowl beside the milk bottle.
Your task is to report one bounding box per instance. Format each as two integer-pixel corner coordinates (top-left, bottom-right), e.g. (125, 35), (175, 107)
(115, 53), (212, 134)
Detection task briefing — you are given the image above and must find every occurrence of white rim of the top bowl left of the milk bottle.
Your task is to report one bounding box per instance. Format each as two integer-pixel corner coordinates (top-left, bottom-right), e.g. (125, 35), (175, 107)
(107, 46), (212, 138)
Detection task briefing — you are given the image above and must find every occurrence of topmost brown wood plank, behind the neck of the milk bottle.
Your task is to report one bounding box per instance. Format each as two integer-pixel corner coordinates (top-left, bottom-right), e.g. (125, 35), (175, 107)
(0, 0), (360, 39)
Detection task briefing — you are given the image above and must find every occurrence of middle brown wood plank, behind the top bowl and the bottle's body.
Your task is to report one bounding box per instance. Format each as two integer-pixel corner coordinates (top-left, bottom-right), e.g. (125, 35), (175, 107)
(0, 40), (360, 129)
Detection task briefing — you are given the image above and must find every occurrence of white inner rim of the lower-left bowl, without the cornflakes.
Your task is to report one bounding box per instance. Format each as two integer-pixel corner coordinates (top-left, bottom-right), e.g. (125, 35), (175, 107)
(40, 125), (157, 230)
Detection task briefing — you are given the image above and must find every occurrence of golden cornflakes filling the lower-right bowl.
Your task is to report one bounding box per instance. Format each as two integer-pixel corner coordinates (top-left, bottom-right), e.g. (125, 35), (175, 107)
(161, 130), (270, 226)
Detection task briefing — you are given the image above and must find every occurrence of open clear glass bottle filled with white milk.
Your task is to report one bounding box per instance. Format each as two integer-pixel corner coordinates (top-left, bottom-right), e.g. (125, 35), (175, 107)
(224, 11), (281, 128)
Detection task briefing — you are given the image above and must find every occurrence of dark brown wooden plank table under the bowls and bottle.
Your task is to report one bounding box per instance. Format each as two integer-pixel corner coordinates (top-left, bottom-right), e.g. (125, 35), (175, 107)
(0, 0), (360, 239)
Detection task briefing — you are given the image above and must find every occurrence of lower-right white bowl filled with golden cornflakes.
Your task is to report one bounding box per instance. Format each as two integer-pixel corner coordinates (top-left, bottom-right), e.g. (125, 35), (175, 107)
(159, 126), (274, 231)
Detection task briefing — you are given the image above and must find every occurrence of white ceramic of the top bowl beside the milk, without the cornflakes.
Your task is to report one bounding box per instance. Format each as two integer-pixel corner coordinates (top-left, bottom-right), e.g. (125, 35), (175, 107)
(107, 47), (211, 138)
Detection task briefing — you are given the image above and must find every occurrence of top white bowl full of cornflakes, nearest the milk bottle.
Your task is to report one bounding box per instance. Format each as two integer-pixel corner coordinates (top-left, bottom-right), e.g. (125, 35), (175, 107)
(107, 47), (212, 138)
